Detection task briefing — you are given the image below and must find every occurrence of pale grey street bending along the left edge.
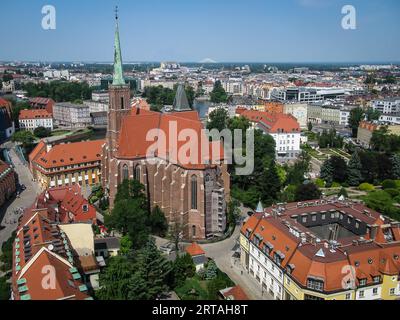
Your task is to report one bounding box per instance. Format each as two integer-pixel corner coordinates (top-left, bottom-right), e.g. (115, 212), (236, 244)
(0, 149), (40, 252)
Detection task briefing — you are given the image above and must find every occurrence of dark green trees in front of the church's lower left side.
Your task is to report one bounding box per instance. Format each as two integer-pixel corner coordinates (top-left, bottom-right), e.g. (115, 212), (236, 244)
(96, 180), (203, 300)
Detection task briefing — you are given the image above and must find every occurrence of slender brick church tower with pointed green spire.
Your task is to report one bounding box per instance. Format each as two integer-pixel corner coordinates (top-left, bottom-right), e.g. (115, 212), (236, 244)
(107, 7), (131, 159)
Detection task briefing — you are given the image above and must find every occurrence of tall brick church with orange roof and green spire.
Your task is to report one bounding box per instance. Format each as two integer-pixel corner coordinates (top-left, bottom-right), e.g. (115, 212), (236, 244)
(102, 17), (230, 240)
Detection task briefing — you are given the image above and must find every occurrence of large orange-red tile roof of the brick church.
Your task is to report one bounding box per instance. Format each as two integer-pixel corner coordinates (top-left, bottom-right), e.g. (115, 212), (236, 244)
(118, 108), (224, 169)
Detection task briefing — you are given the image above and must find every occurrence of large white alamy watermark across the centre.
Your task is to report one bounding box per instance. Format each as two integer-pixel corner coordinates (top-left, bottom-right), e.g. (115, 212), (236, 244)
(146, 121), (254, 176)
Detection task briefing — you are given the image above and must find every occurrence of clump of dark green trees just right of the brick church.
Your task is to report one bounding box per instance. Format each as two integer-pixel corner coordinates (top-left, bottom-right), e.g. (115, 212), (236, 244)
(207, 108), (321, 208)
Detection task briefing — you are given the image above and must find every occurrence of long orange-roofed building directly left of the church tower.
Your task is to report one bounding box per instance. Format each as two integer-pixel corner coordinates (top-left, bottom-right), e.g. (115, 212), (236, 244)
(29, 140), (105, 190)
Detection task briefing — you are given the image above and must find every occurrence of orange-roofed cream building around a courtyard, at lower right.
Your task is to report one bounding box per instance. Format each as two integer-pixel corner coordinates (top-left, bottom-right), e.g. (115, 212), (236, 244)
(241, 200), (400, 300)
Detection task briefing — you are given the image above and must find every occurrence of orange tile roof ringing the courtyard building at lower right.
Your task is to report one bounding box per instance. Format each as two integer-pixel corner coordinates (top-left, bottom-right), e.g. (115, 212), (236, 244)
(241, 200), (400, 292)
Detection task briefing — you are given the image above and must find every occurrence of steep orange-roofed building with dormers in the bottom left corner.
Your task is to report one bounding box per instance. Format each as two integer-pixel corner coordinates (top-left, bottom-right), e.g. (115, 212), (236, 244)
(11, 209), (92, 300)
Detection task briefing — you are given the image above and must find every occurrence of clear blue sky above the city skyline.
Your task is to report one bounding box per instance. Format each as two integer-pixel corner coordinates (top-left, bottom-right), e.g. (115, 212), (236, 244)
(0, 0), (400, 62)
